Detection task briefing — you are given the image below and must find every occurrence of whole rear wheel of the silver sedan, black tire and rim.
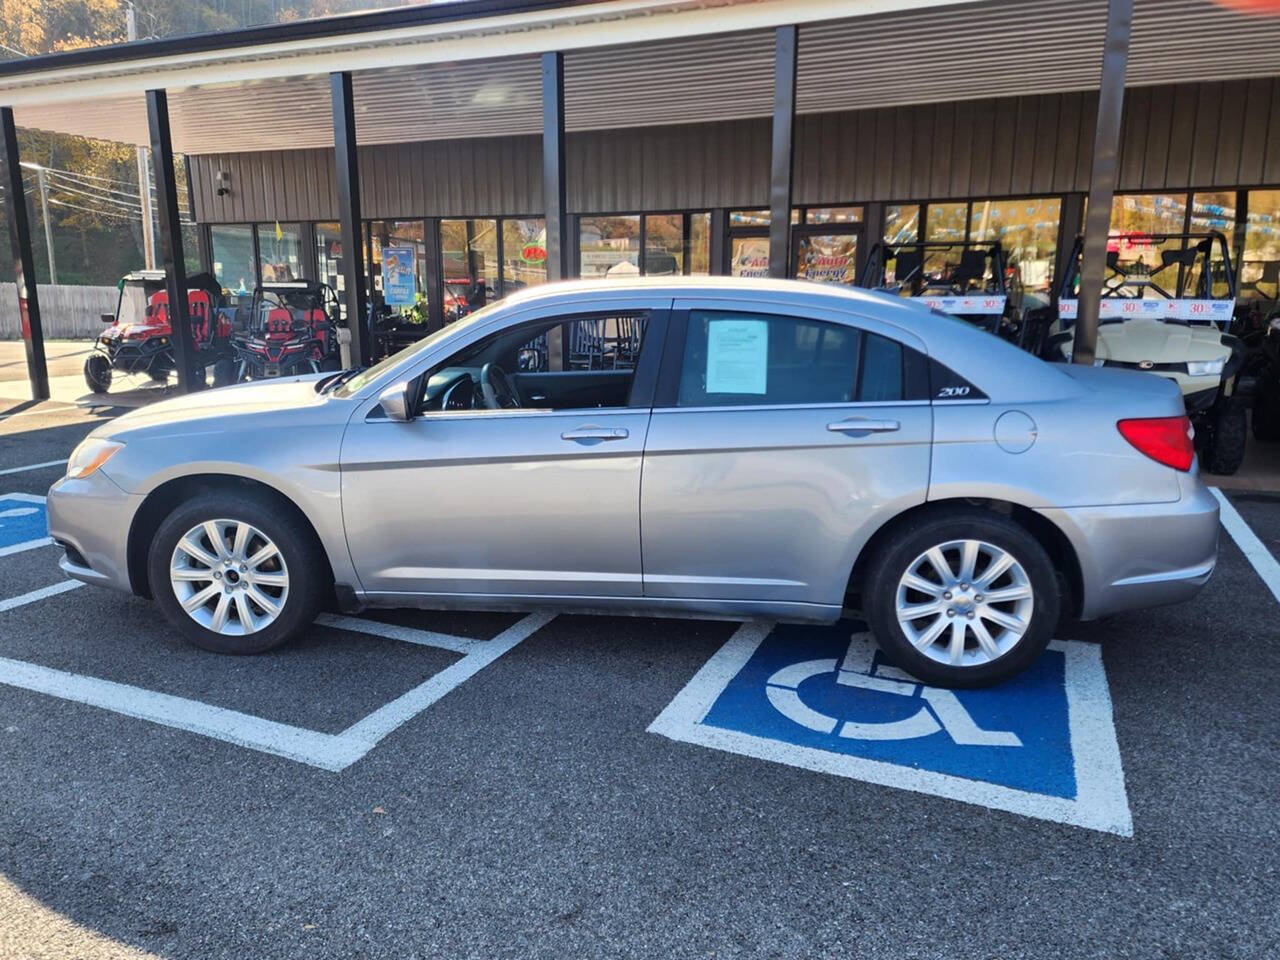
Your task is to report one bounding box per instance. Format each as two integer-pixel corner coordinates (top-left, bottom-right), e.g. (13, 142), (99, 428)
(863, 508), (1062, 687)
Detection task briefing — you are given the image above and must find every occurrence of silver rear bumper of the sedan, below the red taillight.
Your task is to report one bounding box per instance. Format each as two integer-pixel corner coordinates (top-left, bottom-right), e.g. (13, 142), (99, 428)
(1039, 475), (1219, 620)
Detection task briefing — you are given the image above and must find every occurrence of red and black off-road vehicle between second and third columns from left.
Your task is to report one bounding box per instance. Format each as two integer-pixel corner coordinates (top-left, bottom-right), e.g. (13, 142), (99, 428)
(234, 280), (342, 380)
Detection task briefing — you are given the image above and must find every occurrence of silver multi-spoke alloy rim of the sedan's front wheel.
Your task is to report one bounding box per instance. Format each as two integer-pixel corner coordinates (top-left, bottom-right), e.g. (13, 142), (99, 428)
(169, 520), (289, 636)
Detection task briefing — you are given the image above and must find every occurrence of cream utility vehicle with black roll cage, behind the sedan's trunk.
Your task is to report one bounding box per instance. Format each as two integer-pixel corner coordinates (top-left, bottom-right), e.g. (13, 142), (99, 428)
(1042, 230), (1247, 475)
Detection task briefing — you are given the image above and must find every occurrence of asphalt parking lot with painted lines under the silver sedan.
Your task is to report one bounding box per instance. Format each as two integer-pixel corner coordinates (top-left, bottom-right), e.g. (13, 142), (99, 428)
(0, 394), (1280, 960)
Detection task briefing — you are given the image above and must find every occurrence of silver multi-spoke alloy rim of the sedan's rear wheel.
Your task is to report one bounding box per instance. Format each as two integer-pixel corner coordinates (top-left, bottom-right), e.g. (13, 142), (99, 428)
(895, 540), (1036, 667)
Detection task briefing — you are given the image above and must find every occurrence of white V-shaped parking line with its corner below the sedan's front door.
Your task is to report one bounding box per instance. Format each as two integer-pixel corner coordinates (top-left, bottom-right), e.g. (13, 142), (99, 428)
(0, 611), (554, 772)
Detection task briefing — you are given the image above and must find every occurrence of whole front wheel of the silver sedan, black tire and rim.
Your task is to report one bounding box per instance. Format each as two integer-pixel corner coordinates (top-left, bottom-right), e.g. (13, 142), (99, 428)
(147, 489), (332, 654)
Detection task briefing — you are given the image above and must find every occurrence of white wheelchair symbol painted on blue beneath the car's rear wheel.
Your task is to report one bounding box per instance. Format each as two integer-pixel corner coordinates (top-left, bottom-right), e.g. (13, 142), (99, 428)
(764, 634), (1023, 746)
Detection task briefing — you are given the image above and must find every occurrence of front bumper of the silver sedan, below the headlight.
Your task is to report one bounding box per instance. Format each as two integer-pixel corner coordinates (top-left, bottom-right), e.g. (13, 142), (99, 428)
(45, 470), (142, 593)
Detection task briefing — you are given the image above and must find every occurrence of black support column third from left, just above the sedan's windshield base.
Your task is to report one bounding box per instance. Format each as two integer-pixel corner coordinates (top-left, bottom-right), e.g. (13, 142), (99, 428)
(329, 73), (372, 366)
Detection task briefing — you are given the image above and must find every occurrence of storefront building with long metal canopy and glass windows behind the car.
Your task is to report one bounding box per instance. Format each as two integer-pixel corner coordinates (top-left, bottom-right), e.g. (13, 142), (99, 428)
(0, 0), (1280, 386)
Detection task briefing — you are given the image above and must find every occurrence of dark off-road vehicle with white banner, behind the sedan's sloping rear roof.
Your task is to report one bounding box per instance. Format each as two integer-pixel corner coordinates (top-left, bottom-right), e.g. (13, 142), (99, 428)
(859, 241), (1025, 343)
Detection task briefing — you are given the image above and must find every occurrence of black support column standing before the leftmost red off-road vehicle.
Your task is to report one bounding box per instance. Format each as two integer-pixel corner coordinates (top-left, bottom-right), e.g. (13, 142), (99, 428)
(147, 90), (205, 393)
